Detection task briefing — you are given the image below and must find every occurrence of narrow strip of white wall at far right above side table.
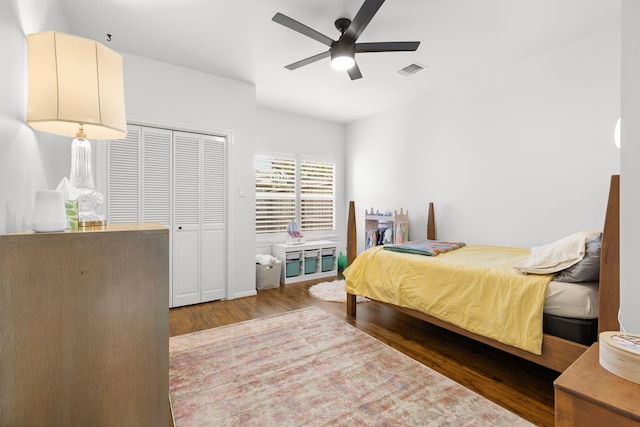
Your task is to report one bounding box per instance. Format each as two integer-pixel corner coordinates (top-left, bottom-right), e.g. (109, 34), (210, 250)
(620, 0), (640, 333)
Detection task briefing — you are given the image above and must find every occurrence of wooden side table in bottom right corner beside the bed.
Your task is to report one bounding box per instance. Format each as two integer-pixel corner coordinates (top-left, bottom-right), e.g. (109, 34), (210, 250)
(554, 343), (640, 427)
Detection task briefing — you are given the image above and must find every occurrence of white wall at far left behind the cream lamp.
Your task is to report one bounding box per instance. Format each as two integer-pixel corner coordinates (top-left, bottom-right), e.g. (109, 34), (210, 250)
(0, 0), (71, 234)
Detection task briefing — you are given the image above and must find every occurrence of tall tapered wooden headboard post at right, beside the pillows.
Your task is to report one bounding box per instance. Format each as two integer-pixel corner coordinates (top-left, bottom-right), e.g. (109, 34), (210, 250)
(598, 175), (620, 334)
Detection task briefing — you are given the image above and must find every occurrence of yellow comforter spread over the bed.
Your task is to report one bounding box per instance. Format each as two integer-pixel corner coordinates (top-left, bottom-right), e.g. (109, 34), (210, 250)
(344, 245), (551, 354)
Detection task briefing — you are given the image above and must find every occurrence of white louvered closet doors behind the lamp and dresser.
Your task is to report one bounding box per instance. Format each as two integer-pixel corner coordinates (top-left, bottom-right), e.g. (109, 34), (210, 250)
(104, 125), (227, 307)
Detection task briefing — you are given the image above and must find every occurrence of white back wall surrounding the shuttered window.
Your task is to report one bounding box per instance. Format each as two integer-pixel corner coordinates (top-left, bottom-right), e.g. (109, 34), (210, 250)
(256, 107), (347, 254)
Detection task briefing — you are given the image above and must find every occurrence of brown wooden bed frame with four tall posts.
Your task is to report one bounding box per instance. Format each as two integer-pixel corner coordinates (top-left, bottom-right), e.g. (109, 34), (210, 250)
(347, 175), (620, 372)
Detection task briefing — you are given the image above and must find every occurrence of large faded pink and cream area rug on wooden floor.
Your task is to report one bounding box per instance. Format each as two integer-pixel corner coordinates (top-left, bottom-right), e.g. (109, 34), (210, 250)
(169, 307), (532, 427)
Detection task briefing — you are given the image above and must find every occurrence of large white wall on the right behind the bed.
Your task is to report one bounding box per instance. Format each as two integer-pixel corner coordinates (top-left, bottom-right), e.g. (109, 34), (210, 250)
(345, 27), (620, 250)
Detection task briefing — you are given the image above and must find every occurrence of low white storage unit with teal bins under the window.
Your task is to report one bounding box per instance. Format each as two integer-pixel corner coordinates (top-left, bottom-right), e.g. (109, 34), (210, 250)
(271, 240), (338, 285)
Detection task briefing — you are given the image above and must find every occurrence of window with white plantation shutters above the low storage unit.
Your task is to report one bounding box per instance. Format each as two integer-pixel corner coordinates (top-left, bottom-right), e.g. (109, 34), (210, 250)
(255, 156), (336, 234)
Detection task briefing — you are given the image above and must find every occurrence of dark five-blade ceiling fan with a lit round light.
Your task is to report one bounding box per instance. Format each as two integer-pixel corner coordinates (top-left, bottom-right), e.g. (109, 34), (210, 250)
(272, 0), (420, 80)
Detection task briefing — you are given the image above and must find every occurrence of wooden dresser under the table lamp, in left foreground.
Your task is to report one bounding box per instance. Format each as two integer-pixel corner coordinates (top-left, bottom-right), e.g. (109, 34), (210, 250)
(0, 224), (169, 426)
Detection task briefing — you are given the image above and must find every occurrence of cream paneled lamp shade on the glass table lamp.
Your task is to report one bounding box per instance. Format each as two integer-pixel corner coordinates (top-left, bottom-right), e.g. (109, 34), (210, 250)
(27, 31), (127, 139)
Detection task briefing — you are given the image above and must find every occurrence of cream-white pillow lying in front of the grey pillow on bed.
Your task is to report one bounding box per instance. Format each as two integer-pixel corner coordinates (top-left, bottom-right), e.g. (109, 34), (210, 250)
(513, 230), (600, 274)
